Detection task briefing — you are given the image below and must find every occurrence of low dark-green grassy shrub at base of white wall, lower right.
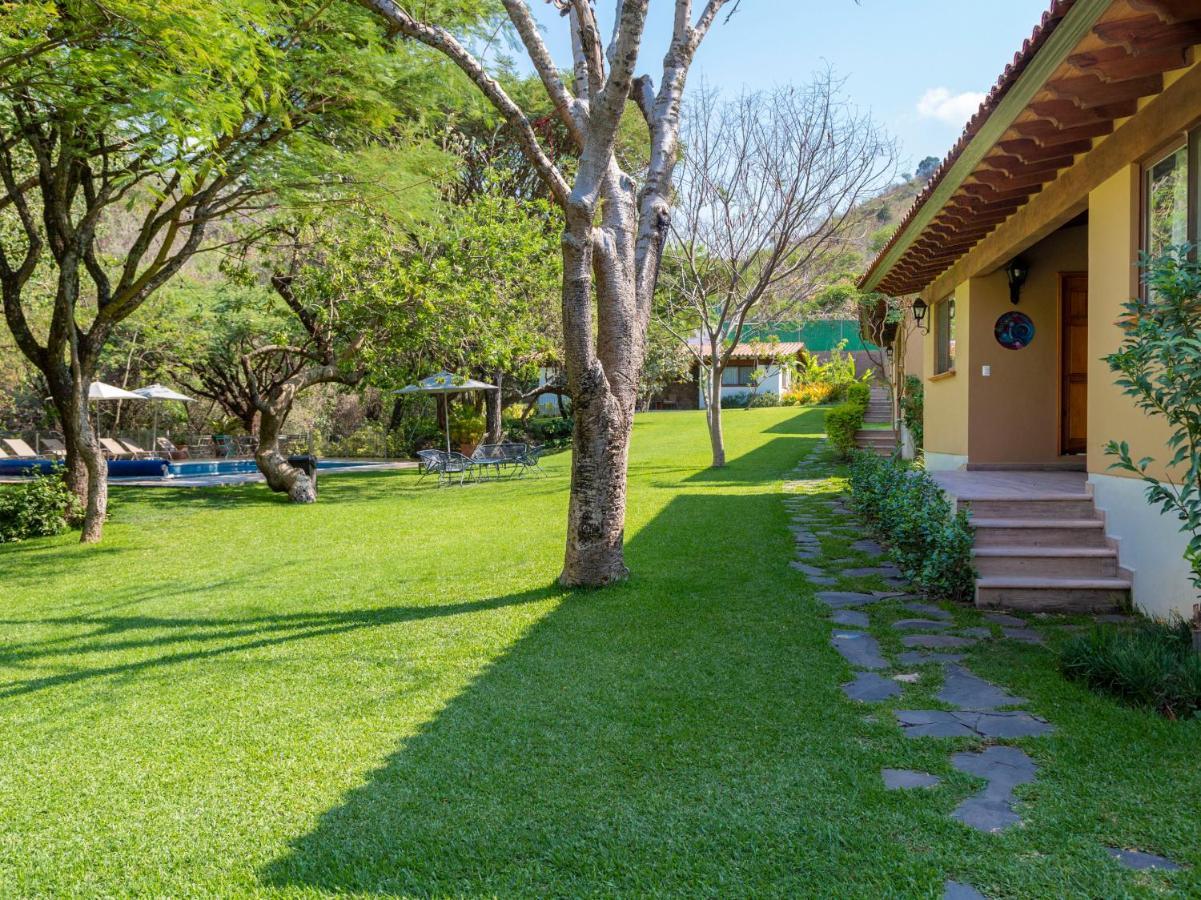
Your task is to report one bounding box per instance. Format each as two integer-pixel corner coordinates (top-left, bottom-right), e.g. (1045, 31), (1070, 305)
(1059, 619), (1201, 719)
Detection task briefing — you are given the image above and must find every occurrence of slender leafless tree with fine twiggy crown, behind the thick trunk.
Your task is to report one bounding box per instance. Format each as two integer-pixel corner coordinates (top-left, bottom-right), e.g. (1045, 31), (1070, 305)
(661, 78), (895, 466)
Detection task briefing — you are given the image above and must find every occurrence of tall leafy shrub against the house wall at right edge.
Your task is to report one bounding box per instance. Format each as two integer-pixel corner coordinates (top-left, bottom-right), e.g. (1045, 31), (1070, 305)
(1105, 246), (1201, 590)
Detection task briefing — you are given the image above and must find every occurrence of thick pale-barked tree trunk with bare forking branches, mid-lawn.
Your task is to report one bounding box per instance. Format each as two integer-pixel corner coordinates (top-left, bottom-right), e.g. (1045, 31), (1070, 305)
(358, 0), (739, 585)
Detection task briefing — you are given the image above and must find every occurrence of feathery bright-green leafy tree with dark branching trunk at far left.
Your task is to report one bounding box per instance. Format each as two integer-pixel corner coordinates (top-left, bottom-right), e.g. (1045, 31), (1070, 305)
(0, 0), (485, 542)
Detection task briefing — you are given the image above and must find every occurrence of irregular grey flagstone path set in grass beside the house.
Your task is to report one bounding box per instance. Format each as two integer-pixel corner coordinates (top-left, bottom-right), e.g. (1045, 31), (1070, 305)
(784, 445), (1179, 898)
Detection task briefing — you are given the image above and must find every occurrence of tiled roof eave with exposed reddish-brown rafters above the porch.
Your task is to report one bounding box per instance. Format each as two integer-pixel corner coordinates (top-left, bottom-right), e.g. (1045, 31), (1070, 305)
(860, 0), (1201, 296)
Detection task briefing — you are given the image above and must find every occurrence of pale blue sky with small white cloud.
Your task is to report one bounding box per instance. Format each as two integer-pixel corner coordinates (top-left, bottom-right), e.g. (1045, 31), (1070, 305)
(518, 0), (1050, 171)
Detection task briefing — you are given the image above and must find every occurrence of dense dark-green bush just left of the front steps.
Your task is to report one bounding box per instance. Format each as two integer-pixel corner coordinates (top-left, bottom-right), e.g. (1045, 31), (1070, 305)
(850, 452), (975, 602)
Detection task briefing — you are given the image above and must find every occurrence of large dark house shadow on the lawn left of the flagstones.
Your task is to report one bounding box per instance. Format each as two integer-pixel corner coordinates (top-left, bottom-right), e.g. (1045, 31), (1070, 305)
(259, 493), (858, 895)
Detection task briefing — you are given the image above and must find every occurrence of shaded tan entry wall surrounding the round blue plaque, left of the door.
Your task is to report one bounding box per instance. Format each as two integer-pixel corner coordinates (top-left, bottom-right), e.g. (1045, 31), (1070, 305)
(967, 226), (1088, 464)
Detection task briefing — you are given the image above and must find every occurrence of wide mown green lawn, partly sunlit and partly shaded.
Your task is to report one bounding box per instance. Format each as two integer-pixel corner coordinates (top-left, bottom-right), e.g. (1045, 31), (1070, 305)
(0, 410), (1201, 898)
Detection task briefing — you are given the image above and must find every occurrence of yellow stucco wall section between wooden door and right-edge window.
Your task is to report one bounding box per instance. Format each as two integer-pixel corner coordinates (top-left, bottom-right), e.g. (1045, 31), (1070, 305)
(1088, 166), (1170, 475)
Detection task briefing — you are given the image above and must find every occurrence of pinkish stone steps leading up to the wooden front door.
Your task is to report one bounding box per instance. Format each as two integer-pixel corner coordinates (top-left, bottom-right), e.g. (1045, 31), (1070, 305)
(957, 487), (1131, 613)
